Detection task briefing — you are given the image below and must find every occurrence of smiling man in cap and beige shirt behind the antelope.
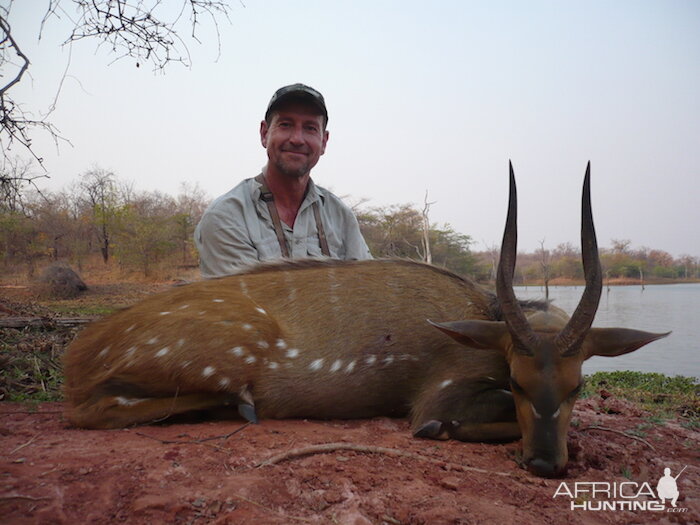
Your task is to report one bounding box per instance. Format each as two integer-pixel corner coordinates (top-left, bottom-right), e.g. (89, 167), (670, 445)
(195, 84), (371, 278)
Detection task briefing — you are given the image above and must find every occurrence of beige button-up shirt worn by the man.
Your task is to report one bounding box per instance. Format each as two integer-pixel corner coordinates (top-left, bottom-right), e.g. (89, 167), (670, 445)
(194, 178), (372, 279)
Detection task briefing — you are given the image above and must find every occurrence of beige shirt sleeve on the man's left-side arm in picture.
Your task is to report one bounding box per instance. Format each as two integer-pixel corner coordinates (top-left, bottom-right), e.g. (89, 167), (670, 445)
(195, 205), (258, 279)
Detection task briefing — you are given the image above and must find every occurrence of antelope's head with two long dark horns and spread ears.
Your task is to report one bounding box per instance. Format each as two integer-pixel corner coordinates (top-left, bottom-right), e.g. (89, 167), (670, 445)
(438, 162), (668, 477)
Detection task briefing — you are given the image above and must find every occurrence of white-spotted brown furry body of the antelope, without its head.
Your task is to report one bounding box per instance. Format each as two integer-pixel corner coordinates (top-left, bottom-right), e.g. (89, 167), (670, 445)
(65, 260), (512, 428)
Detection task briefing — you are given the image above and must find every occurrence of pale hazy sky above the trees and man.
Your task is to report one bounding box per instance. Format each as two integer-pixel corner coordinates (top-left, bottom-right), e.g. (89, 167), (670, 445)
(6, 0), (700, 256)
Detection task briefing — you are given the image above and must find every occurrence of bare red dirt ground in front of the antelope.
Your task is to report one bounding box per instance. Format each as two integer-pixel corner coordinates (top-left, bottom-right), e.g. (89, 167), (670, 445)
(0, 397), (700, 525)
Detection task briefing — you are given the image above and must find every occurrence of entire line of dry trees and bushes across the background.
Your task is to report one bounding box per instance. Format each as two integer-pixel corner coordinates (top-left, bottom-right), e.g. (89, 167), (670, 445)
(0, 166), (700, 283)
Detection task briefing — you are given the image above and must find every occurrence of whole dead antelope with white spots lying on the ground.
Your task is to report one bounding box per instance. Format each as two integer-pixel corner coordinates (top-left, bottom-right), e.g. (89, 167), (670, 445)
(65, 163), (667, 476)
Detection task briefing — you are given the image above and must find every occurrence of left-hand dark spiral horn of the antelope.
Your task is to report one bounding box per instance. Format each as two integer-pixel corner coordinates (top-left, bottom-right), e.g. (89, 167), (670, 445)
(496, 161), (538, 355)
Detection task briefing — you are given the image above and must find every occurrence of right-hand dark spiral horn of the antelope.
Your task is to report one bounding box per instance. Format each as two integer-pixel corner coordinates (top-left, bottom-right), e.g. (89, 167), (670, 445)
(555, 161), (603, 356)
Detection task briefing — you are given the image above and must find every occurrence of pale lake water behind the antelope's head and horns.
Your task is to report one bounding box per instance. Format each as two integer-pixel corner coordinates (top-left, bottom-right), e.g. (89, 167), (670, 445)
(515, 284), (700, 378)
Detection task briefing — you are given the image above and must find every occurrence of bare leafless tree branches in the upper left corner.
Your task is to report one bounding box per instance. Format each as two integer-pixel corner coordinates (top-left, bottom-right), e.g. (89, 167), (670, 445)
(0, 0), (230, 166)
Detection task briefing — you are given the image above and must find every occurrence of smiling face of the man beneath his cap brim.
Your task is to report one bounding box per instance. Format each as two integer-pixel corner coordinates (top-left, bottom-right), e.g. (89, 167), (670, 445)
(260, 101), (328, 178)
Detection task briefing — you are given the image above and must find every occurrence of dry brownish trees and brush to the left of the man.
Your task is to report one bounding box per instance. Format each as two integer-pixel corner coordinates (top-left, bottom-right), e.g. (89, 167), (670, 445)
(0, 167), (206, 276)
